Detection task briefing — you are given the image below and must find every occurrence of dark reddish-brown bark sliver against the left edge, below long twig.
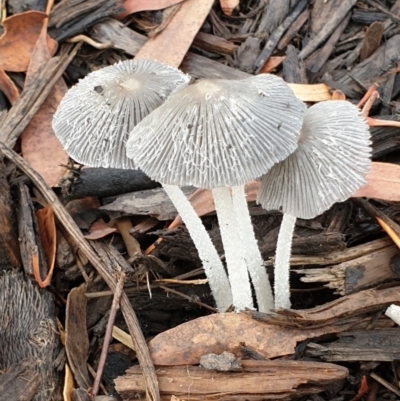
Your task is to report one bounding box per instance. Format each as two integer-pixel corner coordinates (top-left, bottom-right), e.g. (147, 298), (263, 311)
(0, 152), (21, 271)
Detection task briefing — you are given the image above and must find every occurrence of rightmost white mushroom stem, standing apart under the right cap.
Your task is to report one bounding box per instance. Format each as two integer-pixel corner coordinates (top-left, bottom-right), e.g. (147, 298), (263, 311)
(274, 213), (296, 309)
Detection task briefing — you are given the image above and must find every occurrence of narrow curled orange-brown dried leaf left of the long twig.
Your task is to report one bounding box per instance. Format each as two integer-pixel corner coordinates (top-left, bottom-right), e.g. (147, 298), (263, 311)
(35, 205), (57, 288)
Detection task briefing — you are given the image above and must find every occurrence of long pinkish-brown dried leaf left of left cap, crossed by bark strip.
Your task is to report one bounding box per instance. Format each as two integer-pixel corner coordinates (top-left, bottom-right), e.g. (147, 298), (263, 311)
(21, 11), (68, 187)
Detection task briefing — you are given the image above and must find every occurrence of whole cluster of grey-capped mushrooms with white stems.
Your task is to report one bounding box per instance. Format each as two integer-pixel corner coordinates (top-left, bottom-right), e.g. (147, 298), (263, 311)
(53, 60), (370, 312)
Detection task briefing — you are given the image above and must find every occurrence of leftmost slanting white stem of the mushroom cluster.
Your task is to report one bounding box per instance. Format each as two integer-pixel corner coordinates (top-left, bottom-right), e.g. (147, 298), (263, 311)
(163, 184), (232, 312)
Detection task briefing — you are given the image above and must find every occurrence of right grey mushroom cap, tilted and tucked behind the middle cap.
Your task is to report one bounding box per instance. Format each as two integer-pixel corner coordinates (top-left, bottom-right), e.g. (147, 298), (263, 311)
(257, 101), (371, 219)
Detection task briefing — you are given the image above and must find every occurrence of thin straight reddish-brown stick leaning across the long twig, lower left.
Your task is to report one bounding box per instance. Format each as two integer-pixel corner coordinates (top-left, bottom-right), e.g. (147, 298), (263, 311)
(90, 273), (126, 398)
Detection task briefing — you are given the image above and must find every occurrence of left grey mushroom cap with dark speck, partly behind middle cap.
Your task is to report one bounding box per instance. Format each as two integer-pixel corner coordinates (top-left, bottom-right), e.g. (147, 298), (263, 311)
(53, 60), (190, 169)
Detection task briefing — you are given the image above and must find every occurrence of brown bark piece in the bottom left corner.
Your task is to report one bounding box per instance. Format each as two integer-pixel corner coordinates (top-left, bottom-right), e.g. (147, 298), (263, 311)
(0, 359), (41, 401)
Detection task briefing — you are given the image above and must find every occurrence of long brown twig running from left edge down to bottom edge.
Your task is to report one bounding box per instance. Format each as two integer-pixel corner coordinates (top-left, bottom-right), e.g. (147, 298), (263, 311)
(0, 142), (160, 401)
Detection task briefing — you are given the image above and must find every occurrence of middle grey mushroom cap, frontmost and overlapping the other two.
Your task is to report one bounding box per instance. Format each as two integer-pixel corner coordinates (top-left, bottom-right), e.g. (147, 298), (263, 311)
(127, 74), (305, 188)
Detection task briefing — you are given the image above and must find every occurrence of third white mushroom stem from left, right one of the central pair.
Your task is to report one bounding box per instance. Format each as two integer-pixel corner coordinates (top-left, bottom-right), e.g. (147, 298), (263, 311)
(232, 185), (274, 312)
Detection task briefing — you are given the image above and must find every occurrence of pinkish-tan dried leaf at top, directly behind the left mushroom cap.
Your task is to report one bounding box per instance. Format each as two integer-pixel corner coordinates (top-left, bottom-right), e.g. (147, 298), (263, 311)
(135, 0), (214, 67)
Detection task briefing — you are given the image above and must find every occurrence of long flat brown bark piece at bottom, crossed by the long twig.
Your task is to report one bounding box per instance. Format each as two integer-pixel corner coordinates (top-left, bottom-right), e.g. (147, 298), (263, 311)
(115, 360), (348, 401)
